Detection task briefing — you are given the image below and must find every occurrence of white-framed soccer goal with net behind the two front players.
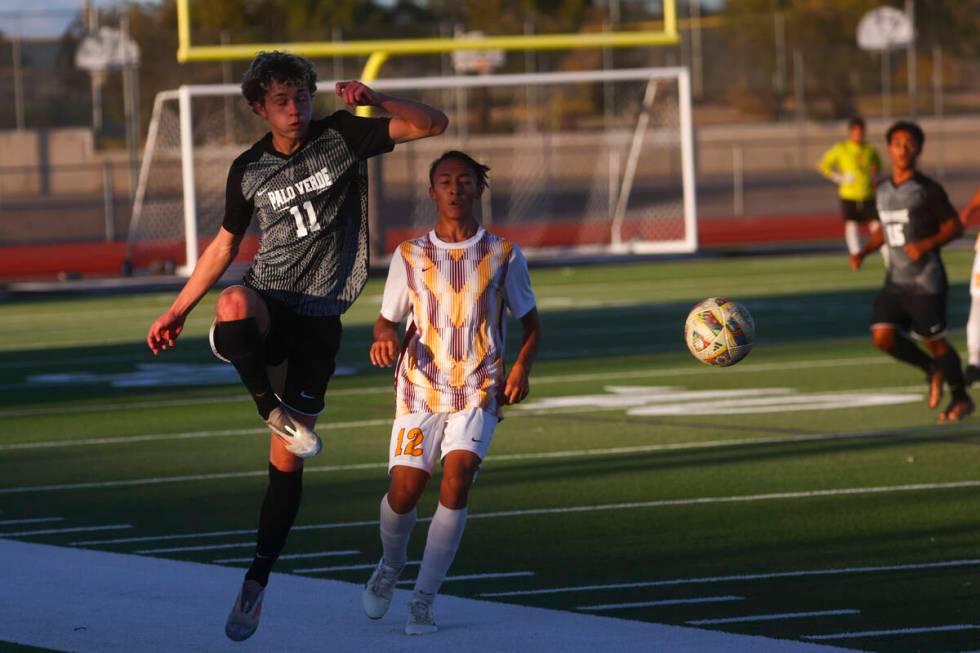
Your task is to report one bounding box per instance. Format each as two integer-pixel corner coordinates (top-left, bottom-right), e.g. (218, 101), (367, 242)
(127, 68), (697, 273)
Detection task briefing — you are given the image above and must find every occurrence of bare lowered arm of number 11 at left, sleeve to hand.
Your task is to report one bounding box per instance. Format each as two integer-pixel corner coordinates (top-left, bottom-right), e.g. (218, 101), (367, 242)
(146, 227), (242, 354)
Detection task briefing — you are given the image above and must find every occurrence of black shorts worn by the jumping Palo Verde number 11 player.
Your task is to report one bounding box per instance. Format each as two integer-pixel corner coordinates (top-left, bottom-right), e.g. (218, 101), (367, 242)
(211, 293), (343, 415)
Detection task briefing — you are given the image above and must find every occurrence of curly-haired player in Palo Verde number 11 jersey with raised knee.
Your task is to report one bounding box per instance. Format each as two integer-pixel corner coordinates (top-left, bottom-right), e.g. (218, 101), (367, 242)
(146, 52), (448, 641)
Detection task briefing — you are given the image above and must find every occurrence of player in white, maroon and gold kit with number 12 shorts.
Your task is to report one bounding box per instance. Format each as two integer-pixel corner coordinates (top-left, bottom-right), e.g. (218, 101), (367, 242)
(361, 151), (541, 635)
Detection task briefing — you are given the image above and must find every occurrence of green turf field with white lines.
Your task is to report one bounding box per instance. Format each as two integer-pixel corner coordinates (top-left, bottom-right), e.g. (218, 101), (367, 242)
(0, 250), (980, 652)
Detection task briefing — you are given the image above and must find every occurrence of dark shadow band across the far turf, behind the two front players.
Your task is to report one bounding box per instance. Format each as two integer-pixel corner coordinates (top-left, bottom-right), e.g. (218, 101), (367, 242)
(0, 284), (969, 407)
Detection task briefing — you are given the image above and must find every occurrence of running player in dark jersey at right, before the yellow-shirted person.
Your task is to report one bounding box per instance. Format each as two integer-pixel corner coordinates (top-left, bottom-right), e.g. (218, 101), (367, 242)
(851, 121), (973, 422)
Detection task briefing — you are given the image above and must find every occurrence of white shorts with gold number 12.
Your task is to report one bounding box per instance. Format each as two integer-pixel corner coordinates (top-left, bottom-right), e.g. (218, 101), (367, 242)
(388, 408), (500, 474)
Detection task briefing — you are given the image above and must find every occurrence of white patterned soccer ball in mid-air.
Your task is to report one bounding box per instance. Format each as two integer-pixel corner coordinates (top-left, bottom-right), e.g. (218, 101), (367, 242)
(684, 297), (755, 367)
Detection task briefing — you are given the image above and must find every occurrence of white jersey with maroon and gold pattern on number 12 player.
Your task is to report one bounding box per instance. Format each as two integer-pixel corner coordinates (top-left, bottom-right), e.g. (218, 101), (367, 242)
(381, 228), (535, 416)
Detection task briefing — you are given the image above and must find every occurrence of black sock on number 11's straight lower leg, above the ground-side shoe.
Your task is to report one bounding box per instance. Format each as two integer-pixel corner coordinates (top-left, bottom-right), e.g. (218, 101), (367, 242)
(245, 463), (303, 587)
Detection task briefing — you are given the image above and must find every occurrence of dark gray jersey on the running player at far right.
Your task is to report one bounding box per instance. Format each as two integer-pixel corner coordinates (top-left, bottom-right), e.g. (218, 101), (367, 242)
(875, 172), (956, 294)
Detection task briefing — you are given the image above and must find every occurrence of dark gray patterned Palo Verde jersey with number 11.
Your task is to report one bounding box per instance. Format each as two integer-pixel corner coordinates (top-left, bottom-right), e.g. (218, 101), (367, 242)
(223, 111), (394, 315)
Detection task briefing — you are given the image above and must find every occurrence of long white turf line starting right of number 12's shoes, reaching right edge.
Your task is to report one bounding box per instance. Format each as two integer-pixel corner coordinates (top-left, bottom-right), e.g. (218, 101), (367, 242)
(480, 558), (980, 597)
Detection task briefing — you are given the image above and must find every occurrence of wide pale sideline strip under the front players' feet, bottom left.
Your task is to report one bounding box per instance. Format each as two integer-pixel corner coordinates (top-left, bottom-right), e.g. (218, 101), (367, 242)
(0, 540), (840, 653)
